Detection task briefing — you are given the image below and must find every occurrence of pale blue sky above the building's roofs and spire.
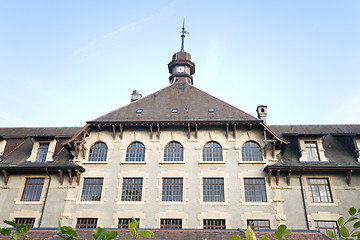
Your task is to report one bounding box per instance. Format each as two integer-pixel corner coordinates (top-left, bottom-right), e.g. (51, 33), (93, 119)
(0, 0), (360, 127)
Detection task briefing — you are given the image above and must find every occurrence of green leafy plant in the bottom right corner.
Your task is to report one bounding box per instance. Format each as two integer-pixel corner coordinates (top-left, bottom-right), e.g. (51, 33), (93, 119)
(327, 207), (360, 240)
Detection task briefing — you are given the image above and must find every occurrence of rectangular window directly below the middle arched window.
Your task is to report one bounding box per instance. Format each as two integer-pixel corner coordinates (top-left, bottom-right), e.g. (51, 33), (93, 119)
(162, 178), (183, 202)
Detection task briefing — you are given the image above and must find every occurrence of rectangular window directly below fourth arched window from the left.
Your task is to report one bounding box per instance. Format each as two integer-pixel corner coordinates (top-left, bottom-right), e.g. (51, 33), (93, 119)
(203, 178), (225, 202)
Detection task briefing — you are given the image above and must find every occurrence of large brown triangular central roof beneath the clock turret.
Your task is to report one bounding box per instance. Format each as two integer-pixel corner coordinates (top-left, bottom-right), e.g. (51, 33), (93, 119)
(89, 81), (260, 123)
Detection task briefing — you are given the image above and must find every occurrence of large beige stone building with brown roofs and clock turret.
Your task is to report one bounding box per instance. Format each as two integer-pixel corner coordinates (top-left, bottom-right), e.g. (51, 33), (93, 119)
(0, 33), (360, 236)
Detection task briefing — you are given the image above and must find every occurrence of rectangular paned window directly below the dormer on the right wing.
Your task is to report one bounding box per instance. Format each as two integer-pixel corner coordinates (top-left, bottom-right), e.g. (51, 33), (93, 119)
(307, 178), (333, 203)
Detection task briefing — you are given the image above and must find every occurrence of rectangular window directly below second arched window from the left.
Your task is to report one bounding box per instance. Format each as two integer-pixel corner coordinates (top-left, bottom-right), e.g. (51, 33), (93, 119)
(121, 178), (142, 201)
